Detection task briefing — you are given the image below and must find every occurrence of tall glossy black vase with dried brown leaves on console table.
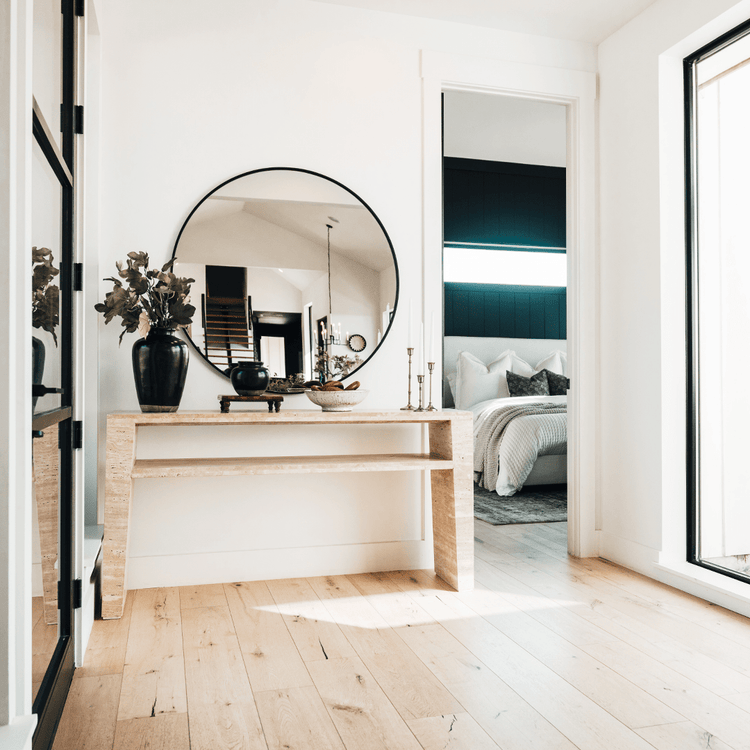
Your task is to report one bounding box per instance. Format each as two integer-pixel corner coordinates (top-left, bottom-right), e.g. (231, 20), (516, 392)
(95, 252), (195, 412)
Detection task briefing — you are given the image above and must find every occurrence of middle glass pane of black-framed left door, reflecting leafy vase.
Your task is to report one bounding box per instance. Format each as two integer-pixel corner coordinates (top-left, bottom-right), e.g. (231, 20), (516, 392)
(31, 141), (62, 413)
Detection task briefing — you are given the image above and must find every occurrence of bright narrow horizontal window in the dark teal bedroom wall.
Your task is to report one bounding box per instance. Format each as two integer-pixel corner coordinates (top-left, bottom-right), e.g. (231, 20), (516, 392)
(443, 247), (567, 286)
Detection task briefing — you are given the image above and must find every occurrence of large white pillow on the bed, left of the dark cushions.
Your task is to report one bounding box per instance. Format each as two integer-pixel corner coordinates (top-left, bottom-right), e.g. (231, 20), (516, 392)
(454, 350), (534, 409)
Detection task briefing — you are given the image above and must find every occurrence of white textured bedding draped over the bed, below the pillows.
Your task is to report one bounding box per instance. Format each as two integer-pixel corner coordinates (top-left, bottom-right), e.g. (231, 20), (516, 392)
(471, 396), (567, 497)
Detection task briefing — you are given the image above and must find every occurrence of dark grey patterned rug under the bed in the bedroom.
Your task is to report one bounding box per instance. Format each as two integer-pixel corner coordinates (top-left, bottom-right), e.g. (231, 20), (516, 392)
(474, 484), (568, 526)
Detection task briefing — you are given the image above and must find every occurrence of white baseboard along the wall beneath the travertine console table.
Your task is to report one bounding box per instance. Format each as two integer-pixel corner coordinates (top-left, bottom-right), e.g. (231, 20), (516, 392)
(127, 540), (433, 589)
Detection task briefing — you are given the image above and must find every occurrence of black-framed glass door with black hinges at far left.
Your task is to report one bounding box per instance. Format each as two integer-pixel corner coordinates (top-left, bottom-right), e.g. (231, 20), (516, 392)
(29, 0), (77, 750)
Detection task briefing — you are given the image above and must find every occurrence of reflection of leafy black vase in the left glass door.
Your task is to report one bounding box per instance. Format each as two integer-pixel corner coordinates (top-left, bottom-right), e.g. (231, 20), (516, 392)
(31, 247), (60, 411)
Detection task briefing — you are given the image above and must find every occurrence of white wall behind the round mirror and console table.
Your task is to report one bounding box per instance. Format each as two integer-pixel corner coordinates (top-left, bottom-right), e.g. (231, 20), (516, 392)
(95, 0), (595, 586)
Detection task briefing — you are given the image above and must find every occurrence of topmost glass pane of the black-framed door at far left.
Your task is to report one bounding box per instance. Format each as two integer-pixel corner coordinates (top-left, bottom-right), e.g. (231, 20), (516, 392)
(32, 0), (62, 151)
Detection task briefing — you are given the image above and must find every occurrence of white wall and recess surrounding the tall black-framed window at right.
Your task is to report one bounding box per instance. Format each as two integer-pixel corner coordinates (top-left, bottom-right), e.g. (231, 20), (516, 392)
(599, 0), (750, 594)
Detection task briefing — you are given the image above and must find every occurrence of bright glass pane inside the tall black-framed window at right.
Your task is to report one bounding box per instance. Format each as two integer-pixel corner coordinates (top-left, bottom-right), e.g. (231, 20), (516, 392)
(697, 39), (750, 573)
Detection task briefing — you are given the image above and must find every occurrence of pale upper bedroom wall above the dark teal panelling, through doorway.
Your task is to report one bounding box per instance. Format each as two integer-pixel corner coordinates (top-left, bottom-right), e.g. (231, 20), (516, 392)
(444, 91), (567, 167)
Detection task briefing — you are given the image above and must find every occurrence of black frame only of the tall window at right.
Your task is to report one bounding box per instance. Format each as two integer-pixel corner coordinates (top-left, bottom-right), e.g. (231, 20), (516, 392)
(683, 14), (750, 583)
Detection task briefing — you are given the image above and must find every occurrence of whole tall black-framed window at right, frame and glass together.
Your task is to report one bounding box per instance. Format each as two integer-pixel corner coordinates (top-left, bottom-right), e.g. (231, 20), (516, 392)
(684, 14), (750, 582)
